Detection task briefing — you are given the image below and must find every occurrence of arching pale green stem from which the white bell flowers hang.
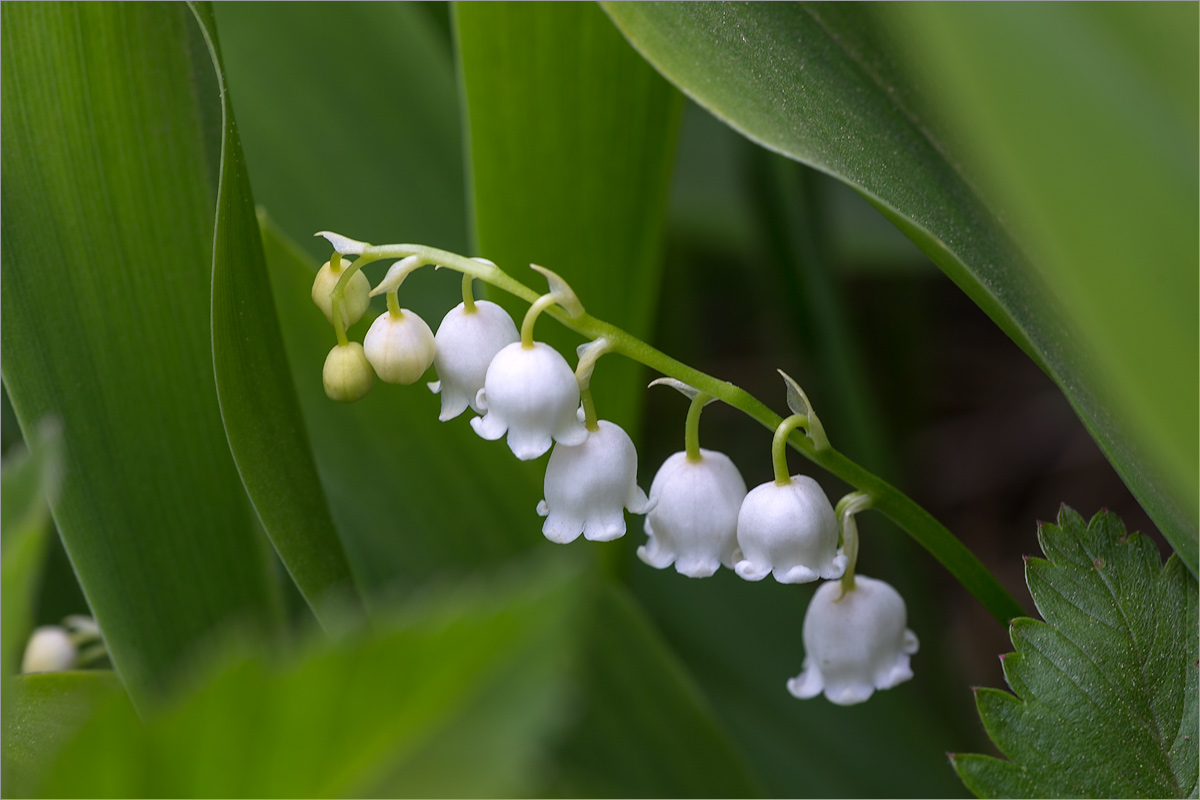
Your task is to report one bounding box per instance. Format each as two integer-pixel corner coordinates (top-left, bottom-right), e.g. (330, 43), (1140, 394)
(331, 237), (1026, 625)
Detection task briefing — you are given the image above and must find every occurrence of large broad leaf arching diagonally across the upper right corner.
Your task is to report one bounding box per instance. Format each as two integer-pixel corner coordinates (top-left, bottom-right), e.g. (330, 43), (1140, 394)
(605, 2), (1200, 573)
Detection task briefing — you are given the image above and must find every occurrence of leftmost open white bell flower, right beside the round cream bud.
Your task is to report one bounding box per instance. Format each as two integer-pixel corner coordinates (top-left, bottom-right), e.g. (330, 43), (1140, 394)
(430, 300), (521, 422)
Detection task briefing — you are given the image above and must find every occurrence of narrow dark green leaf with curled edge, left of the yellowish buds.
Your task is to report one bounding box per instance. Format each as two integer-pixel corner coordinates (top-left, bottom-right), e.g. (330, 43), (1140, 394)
(187, 6), (361, 619)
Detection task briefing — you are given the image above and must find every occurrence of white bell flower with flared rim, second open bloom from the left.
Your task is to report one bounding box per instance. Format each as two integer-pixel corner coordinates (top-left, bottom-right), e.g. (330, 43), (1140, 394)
(470, 342), (588, 461)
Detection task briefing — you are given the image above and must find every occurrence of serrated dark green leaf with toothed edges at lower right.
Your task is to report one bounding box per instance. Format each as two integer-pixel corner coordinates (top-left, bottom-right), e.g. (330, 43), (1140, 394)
(952, 506), (1200, 798)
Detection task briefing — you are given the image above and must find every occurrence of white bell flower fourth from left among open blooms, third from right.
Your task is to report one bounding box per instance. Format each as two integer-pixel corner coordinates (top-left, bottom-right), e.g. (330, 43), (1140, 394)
(637, 447), (746, 578)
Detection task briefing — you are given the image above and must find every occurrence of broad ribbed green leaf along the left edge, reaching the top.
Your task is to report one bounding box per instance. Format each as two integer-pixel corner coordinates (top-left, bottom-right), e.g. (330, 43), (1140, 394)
(0, 4), (277, 704)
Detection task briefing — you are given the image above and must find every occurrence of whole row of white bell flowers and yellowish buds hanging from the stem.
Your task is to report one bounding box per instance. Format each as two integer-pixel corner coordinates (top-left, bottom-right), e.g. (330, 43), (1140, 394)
(313, 242), (917, 704)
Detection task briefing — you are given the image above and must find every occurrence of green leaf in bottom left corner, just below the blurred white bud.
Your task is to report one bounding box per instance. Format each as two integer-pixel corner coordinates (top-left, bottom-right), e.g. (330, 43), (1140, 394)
(2, 670), (136, 798)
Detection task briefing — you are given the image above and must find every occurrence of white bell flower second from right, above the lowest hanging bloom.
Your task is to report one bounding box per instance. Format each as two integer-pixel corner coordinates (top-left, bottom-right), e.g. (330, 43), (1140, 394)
(733, 475), (846, 583)
